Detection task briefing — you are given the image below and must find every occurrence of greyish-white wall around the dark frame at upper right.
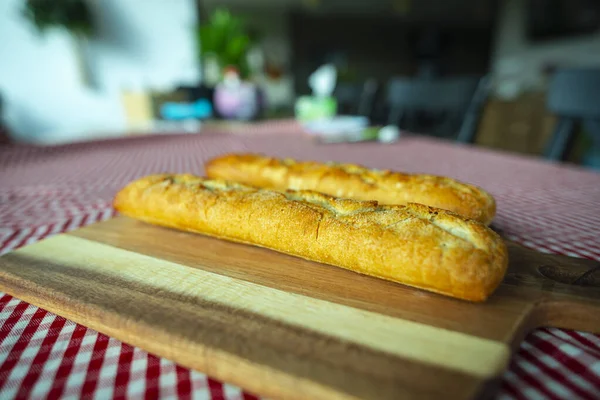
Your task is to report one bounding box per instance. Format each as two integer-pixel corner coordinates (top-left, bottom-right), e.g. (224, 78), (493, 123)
(492, 0), (600, 97)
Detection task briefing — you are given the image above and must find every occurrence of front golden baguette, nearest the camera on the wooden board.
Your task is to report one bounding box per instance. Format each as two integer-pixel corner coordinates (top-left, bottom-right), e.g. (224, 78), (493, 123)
(114, 174), (508, 302)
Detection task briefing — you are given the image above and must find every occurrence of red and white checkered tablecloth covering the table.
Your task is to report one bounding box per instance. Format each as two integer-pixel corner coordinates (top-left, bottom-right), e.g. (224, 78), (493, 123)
(0, 123), (600, 399)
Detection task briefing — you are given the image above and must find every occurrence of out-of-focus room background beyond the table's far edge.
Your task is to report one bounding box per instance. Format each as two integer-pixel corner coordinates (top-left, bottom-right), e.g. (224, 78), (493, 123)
(0, 0), (600, 169)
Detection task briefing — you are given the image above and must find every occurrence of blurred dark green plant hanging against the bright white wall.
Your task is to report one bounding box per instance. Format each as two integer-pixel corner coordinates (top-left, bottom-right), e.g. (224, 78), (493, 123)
(23, 0), (95, 84)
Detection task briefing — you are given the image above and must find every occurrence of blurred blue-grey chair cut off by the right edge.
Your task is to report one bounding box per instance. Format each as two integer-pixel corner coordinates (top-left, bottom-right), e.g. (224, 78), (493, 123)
(544, 69), (600, 161)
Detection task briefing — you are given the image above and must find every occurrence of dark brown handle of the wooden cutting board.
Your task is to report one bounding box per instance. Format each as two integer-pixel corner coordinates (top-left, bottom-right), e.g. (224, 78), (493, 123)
(505, 242), (600, 333)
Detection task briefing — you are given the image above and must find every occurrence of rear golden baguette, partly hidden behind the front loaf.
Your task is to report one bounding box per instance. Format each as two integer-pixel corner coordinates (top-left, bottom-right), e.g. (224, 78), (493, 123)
(205, 154), (496, 225)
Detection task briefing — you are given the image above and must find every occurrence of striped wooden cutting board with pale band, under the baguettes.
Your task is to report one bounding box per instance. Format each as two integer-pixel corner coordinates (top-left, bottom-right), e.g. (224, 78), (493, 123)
(0, 217), (600, 399)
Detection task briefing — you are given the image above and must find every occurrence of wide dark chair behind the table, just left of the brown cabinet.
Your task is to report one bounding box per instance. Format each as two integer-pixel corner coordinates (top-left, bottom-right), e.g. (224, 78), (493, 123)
(387, 77), (489, 143)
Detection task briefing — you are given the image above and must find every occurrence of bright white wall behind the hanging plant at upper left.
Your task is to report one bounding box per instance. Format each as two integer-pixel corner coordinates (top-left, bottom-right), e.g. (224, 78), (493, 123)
(0, 0), (200, 143)
